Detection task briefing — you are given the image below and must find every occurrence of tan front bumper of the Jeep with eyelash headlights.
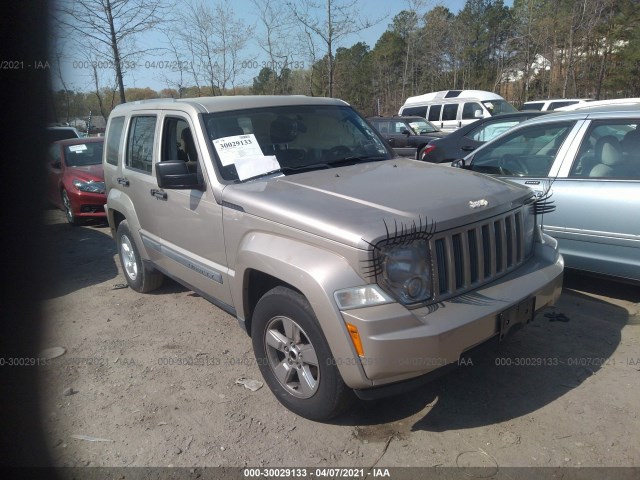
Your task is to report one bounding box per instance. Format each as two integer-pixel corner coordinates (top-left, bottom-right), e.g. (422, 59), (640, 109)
(335, 235), (564, 389)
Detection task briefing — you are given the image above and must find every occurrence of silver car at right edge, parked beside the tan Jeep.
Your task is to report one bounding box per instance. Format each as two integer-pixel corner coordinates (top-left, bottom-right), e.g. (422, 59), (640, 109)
(454, 104), (640, 281)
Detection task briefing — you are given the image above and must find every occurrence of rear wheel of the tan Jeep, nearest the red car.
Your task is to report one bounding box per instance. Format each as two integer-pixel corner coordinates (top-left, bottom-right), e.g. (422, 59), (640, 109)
(116, 220), (164, 293)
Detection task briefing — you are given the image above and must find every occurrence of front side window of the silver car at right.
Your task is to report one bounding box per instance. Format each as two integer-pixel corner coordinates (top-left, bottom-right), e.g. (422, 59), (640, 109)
(471, 122), (575, 177)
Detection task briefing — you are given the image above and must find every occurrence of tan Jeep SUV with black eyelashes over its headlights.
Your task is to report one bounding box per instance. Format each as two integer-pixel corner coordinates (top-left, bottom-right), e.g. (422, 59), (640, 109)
(103, 96), (563, 420)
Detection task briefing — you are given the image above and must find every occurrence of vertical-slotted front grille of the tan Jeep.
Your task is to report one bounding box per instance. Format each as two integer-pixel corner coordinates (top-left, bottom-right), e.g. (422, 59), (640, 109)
(430, 207), (526, 300)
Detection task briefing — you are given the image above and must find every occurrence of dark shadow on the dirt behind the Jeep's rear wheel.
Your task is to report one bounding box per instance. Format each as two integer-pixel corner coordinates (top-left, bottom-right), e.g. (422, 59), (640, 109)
(43, 210), (118, 299)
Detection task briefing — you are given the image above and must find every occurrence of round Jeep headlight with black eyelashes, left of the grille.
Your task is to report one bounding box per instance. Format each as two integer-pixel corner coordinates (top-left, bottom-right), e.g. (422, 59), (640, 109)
(379, 240), (431, 305)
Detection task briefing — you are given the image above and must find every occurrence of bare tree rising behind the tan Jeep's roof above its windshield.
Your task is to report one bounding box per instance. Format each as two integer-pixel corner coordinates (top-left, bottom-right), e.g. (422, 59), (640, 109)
(287, 0), (382, 97)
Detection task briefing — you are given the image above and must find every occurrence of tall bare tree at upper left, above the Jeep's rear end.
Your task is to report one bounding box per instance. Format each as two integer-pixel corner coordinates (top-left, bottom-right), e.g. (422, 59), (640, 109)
(55, 0), (167, 103)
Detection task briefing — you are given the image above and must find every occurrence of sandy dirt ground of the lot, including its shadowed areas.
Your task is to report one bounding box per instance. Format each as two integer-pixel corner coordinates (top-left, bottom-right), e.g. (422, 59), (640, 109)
(38, 210), (640, 469)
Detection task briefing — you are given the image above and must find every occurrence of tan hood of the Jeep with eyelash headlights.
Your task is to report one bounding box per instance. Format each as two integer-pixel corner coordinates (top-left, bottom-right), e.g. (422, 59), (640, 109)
(223, 159), (531, 248)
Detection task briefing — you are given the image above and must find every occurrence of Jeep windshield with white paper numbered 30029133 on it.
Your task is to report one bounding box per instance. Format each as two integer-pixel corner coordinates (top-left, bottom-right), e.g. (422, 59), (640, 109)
(208, 105), (393, 181)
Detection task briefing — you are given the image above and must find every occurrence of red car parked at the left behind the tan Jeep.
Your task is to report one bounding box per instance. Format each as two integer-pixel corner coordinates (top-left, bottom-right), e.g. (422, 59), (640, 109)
(47, 137), (107, 226)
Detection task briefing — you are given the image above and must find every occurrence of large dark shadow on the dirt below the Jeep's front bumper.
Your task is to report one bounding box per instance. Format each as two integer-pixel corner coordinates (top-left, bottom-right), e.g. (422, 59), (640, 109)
(336, 278), (630, 434)
